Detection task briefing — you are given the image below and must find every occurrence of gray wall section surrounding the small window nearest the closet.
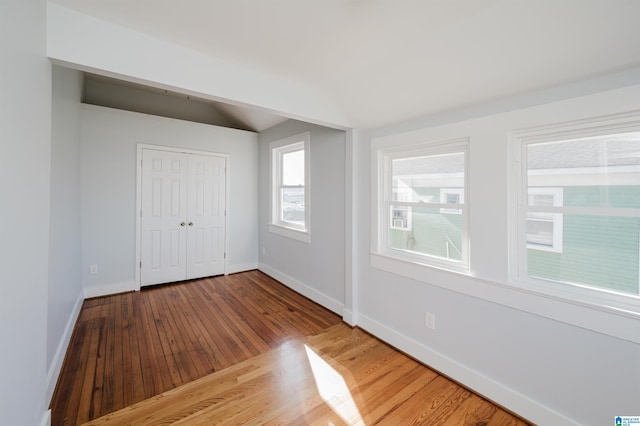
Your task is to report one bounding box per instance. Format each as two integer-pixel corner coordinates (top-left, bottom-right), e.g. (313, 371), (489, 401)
(260, 120), (345, 314)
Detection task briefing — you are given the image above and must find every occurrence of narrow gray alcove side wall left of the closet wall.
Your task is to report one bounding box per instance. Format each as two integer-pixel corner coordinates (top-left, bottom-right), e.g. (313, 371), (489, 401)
(47, 66), (83, 400)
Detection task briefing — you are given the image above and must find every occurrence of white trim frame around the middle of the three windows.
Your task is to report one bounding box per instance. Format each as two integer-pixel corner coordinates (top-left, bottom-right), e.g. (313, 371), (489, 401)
(371, 138), (470, 278)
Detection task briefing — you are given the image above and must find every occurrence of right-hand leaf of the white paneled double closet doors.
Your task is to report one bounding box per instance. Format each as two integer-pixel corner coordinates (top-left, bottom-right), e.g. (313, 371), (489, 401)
(186, 154), (226, 279)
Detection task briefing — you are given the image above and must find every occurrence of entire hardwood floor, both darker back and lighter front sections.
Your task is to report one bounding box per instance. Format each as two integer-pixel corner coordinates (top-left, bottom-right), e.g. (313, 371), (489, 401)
(52, 271), (526, 425)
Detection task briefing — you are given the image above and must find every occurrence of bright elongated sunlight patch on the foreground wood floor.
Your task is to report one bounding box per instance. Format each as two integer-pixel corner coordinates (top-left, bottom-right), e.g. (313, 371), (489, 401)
(304, 345), (365, 425)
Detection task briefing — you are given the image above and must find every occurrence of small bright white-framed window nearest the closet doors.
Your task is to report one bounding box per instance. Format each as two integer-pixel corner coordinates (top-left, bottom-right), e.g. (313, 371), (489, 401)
(269, 132), (310, 242)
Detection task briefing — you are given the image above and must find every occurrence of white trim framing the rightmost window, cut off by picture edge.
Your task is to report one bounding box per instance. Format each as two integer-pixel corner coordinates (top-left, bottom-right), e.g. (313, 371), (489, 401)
(508, 111), (640, 322)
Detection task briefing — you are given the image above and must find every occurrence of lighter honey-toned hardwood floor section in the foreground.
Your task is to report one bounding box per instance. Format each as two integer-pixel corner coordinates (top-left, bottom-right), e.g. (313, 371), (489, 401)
(86, 324), (525, 426)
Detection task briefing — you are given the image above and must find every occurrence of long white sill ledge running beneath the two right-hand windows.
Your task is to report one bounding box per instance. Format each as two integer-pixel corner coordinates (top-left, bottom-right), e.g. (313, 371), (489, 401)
(370, 253), (640, 343)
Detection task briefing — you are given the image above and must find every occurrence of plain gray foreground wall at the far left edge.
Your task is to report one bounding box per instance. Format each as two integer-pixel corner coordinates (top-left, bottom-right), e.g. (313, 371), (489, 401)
(0, 0), (51, 426)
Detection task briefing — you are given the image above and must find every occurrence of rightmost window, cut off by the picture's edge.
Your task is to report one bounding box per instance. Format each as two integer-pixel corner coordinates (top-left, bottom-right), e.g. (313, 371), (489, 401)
(517, 130), (640, 303)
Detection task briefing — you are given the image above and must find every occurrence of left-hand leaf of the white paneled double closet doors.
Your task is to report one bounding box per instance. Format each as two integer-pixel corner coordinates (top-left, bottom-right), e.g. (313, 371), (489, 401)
(140, 149), (187, 285)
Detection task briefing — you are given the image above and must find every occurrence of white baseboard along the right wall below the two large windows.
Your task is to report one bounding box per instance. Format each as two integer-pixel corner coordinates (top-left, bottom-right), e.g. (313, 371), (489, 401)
(358, 313), (577, 425)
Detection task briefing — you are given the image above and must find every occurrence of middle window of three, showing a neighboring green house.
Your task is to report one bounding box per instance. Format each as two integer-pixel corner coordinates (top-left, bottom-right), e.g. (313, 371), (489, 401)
(374, 139), (468, 271)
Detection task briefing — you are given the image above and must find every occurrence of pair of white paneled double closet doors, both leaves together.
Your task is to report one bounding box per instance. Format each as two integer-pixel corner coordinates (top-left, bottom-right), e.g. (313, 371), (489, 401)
(140, 148), (226, 286)
